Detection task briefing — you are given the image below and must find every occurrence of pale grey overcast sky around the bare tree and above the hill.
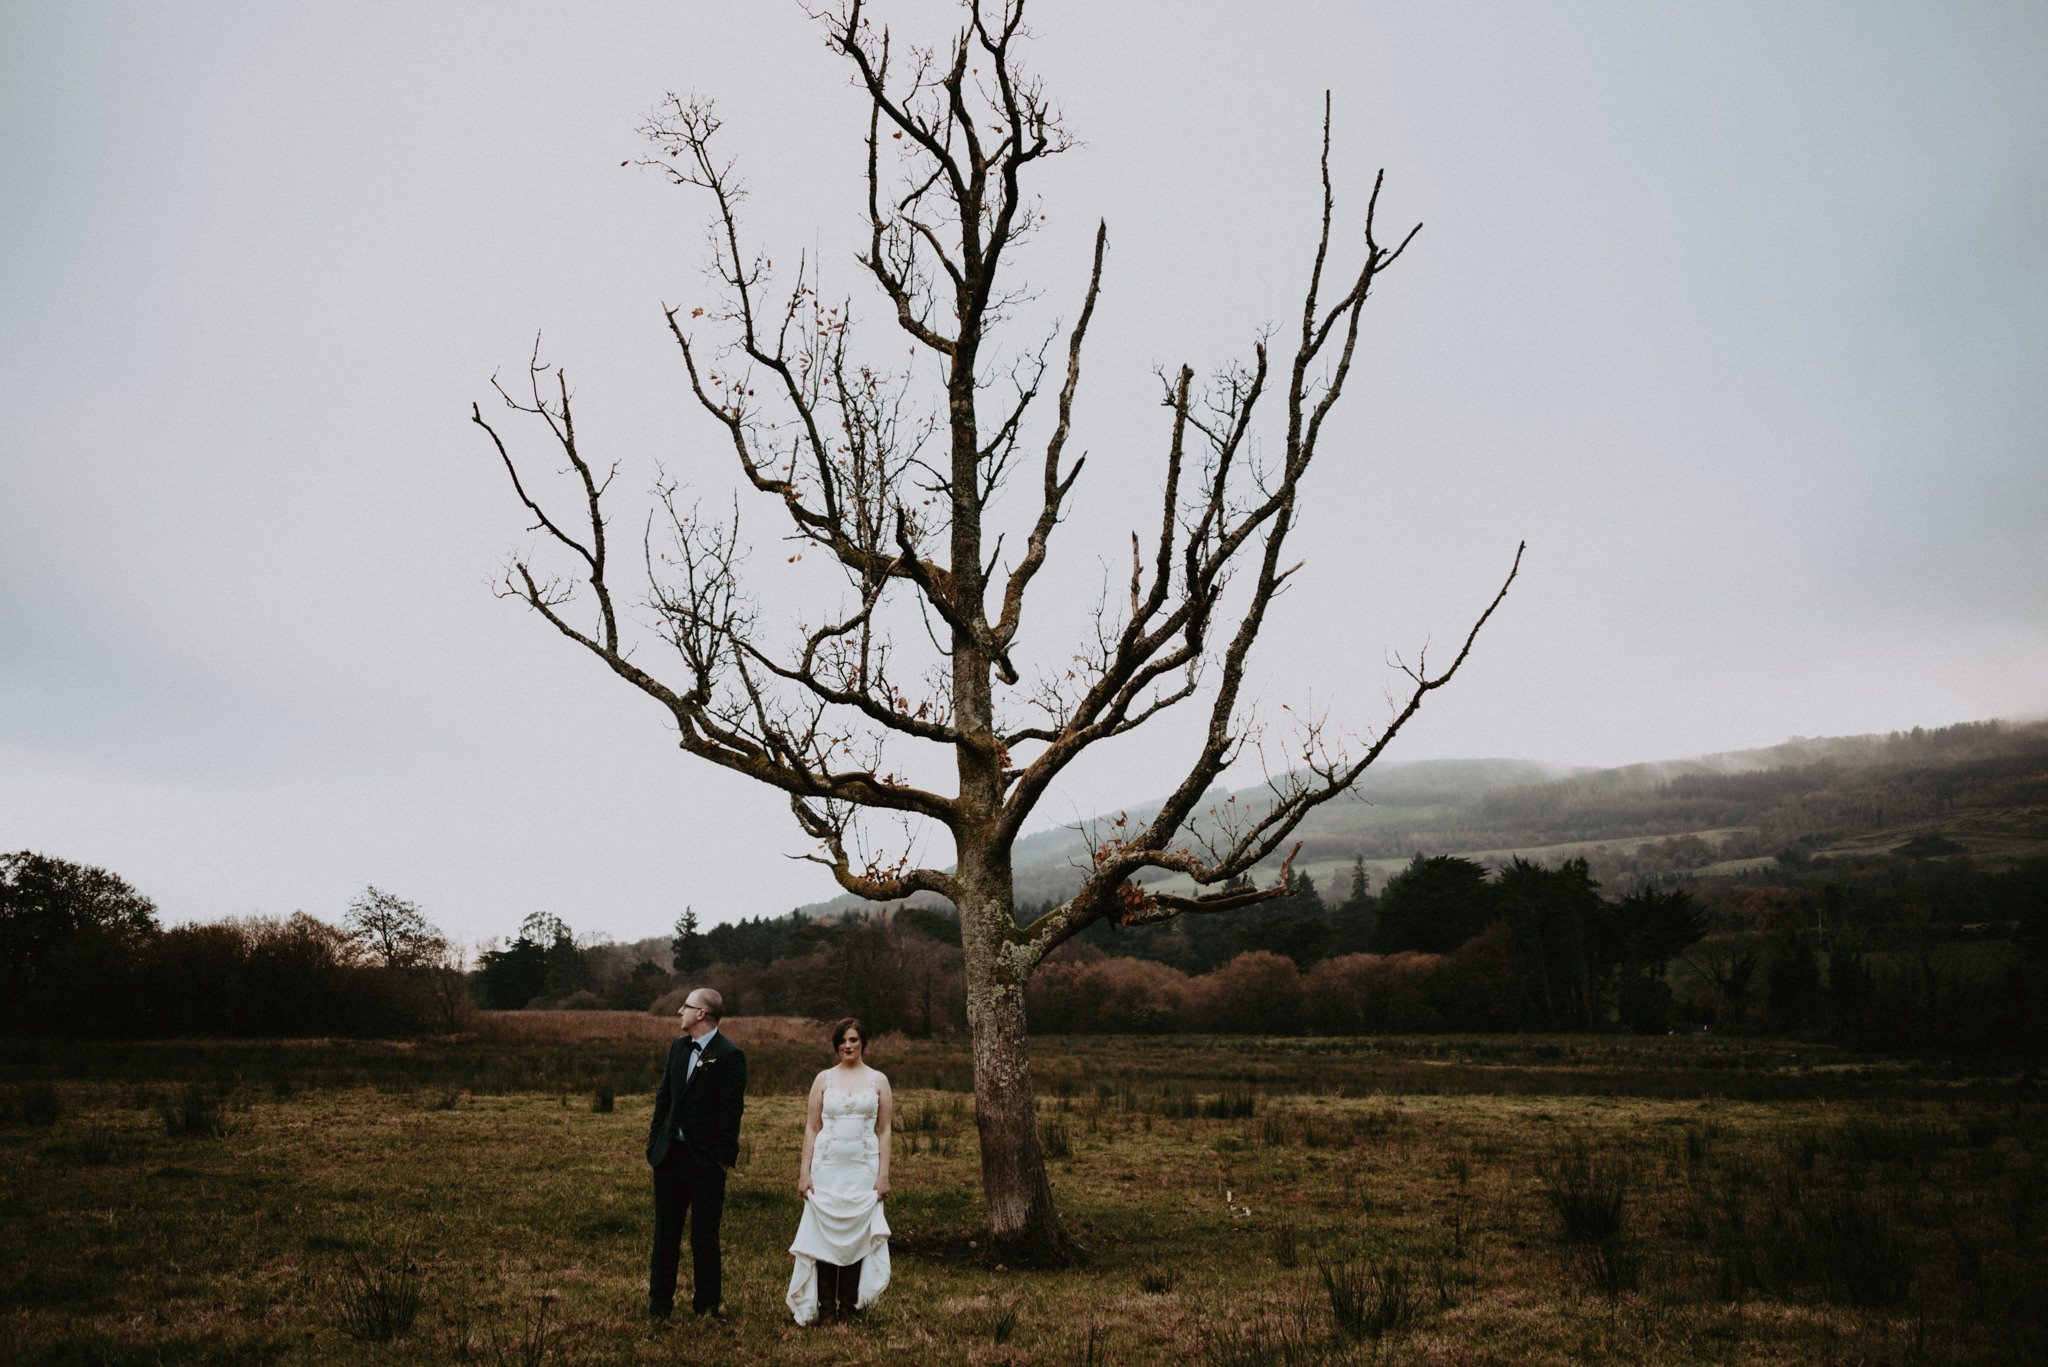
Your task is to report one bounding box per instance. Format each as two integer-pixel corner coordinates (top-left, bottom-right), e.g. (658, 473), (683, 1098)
(0, 0), (2048, 941)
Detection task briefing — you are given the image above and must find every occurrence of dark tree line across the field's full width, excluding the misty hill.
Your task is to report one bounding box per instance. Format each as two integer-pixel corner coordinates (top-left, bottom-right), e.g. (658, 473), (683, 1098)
(0, 836), (2048, 1051)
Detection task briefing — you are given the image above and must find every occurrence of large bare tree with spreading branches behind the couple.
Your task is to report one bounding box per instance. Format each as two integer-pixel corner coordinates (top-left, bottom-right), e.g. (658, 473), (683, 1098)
(473, 0), (1520, 1258)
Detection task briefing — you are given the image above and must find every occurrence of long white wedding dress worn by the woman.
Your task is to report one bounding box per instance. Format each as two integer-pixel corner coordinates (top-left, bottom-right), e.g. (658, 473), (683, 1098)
(784, 1086), (889, 1324)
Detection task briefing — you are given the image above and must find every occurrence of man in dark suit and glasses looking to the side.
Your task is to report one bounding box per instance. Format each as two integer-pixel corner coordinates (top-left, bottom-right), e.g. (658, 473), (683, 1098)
(647, 988), (748, 1320)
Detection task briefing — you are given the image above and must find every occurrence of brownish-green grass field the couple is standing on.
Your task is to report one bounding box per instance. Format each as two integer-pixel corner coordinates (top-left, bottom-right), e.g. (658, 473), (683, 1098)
(0, 1017), (2048, 1367)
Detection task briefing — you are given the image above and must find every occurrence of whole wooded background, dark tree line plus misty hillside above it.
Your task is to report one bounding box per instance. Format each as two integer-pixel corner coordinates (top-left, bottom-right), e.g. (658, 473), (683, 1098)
(0, 721), (2048, 1053)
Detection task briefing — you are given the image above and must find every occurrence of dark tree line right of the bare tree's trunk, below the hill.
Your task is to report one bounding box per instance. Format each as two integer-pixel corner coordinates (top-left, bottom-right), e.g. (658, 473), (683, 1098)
(1032, 836), (2048, 1053)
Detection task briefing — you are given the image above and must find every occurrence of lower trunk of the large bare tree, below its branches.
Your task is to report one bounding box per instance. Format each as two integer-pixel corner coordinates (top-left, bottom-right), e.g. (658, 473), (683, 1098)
(961, 851), (1073, 1265)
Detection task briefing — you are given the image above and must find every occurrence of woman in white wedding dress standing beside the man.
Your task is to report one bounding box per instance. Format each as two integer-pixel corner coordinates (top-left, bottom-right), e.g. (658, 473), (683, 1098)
(784, 1019), (895, 1324)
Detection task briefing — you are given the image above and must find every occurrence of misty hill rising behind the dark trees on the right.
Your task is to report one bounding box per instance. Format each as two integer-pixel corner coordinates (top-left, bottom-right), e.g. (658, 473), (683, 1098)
(803, 721), (2048, 914)
